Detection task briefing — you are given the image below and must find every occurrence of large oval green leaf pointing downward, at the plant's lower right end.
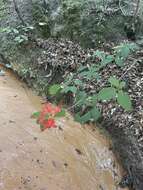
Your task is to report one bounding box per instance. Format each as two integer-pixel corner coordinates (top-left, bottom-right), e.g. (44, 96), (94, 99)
(117, 91), (132, 111)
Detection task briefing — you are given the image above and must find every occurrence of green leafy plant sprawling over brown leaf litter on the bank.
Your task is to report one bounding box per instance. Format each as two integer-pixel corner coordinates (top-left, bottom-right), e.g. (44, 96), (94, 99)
(49, 43), (138, 124)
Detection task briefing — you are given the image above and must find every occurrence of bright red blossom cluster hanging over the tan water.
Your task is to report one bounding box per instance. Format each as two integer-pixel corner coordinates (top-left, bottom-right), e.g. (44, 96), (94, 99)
(33, 103), (61, 131)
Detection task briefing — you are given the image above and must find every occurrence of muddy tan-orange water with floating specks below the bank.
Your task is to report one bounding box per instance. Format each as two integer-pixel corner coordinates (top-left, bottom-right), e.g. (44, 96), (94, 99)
(0, 65), (127, 190)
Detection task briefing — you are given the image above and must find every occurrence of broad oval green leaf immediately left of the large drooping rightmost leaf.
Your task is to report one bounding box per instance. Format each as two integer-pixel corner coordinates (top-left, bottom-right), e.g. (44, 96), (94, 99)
(98, 87), (116, 100)
